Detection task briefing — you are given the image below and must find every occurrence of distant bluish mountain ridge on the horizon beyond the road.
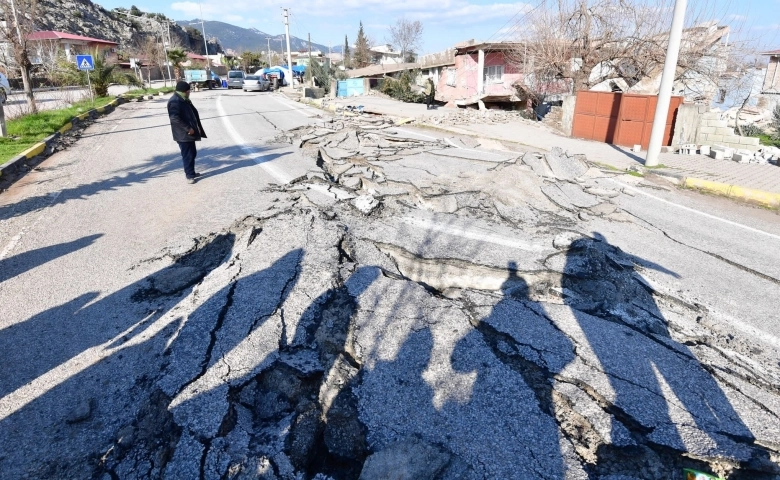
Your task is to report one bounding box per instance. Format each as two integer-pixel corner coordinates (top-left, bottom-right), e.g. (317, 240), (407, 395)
(176, 19), (335, 54)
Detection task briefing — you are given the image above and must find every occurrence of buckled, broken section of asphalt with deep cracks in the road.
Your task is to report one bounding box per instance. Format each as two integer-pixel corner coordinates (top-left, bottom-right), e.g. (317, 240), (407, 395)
(10, 117), (780, 480)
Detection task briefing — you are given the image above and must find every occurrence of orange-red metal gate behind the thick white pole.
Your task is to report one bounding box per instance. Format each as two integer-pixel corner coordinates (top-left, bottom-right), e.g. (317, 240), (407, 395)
(572, 91), (683, 149)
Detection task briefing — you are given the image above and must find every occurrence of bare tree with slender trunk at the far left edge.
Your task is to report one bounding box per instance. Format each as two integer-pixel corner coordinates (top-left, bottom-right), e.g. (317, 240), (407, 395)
(0, 0), (38, 113)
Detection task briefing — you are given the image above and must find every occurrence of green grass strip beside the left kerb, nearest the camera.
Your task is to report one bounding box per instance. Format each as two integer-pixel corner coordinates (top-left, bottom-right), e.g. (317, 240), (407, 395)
(0, 97), (114, 165)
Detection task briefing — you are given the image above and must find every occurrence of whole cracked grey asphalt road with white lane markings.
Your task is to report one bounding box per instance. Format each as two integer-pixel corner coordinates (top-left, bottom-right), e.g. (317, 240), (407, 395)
(0, 91), (780, 480)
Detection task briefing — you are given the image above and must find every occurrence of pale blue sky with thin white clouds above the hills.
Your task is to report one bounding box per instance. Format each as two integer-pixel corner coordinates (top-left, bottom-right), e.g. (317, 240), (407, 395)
(95, 0), (780, 53)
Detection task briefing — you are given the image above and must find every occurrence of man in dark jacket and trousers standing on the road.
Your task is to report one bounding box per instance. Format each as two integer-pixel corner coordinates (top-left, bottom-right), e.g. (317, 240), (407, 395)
(168, 81), (206, 183)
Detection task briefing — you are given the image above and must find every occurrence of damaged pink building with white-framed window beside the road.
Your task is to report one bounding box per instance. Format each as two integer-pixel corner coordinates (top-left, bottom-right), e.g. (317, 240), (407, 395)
(421, 42), (526, 108)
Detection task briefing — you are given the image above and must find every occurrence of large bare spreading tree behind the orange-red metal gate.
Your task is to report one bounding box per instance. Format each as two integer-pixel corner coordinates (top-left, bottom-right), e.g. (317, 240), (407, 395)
(509, 0), (729, 102)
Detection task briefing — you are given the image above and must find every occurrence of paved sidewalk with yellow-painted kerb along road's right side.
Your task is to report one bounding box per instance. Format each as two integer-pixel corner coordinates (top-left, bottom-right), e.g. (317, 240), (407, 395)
(330, 96), (780, 207)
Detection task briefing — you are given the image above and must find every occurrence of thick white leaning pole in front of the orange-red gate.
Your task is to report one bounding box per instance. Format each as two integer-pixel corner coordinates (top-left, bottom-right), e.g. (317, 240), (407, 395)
(645, 0), (688, 167)
